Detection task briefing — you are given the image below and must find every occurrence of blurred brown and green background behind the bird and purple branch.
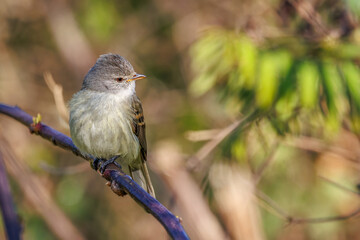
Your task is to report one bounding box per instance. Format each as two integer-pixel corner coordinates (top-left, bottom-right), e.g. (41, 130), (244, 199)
(0, 0), (360, 240)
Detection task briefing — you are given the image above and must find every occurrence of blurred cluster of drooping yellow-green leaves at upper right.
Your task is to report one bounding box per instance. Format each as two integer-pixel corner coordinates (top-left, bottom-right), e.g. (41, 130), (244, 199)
(190, 29), (360, 134)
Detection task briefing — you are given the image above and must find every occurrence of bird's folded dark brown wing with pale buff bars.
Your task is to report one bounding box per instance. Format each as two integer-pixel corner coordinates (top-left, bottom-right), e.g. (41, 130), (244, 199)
(132, 97), (147, 161)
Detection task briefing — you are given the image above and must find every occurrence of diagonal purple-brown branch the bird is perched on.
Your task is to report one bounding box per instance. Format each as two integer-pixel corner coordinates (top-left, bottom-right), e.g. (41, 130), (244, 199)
(0, 103), (189, 239)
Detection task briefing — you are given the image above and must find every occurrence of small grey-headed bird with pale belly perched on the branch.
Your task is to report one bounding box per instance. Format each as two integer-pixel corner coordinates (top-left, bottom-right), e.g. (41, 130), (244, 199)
(69, 53), (155, 197)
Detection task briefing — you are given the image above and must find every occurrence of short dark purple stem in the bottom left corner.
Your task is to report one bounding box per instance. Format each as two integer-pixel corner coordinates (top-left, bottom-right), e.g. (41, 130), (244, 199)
(0, 152), (22, 240)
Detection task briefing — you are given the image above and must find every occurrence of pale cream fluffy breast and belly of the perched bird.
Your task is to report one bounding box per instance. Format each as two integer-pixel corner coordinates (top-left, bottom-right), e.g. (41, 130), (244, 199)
(69, 91), (140, 164)
